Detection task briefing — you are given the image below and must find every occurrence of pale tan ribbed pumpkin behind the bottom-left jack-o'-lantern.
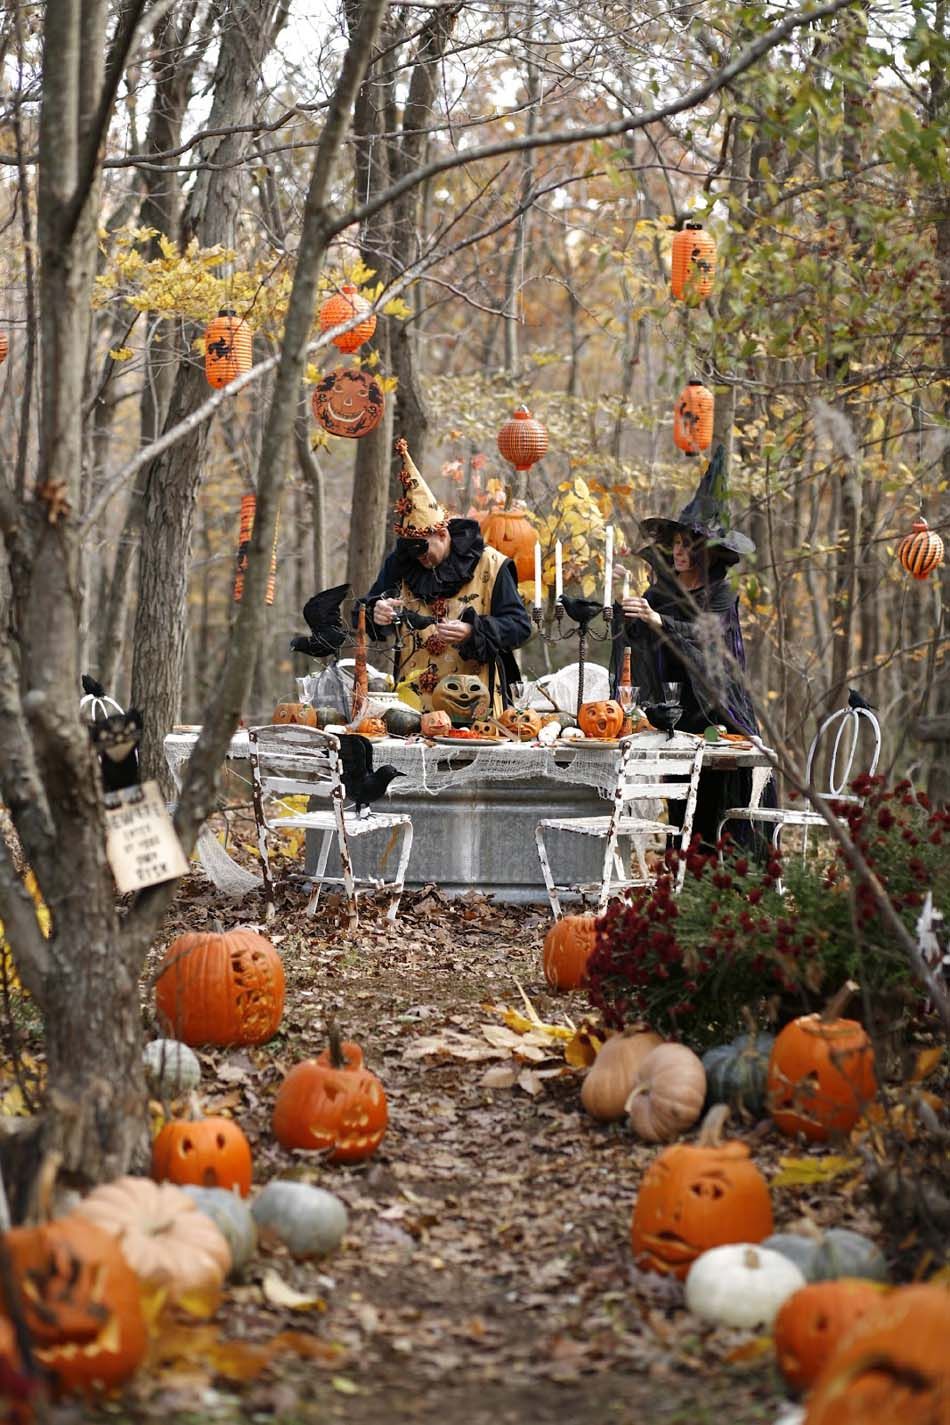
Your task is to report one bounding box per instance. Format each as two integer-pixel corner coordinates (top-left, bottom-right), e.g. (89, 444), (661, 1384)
(75, 1177), (231, 1302)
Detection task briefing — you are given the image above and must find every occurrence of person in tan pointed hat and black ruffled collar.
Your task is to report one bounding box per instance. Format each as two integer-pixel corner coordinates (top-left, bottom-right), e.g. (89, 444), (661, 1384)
(366, 440), (531, 713)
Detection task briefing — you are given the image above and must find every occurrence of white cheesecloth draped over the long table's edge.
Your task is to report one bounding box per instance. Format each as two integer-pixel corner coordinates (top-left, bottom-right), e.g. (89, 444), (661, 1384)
(165, 728), (771, 896)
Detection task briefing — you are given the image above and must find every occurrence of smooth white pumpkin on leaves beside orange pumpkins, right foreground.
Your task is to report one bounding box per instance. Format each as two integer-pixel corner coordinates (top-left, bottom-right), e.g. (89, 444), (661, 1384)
(687, 1243), (805, 1327)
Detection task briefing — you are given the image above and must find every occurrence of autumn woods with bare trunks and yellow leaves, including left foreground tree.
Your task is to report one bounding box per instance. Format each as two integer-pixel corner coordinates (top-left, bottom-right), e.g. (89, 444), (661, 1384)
(0, 0), (950, 1176)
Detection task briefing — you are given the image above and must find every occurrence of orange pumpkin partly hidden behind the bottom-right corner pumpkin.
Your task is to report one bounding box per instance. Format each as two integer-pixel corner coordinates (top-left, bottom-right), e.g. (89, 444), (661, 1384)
(772, 1277), (882, 1391)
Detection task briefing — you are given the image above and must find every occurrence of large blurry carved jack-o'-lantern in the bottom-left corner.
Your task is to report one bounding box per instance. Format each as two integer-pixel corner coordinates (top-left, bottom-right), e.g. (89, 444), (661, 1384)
(0, 1216), (148, 1391)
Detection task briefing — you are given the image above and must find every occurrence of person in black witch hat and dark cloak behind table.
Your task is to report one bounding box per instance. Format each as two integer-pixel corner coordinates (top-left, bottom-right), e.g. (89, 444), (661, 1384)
(614, 446), (773, 849)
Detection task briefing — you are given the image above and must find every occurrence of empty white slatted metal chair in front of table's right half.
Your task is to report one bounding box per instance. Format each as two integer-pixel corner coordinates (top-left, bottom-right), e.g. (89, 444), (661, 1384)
(534, 735), (705, 919)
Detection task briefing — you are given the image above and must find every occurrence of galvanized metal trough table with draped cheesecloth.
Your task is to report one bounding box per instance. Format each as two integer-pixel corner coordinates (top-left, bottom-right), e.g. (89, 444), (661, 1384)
(165, 732), (769, 902)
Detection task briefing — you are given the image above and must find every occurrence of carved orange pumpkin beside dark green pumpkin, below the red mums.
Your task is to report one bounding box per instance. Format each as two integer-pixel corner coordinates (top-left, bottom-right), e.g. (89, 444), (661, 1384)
(768, 1015), (877, 1143)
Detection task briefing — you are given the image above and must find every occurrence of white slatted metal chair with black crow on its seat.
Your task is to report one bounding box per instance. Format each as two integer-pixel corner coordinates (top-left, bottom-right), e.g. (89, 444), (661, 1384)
(248, 724), (412, 922)
